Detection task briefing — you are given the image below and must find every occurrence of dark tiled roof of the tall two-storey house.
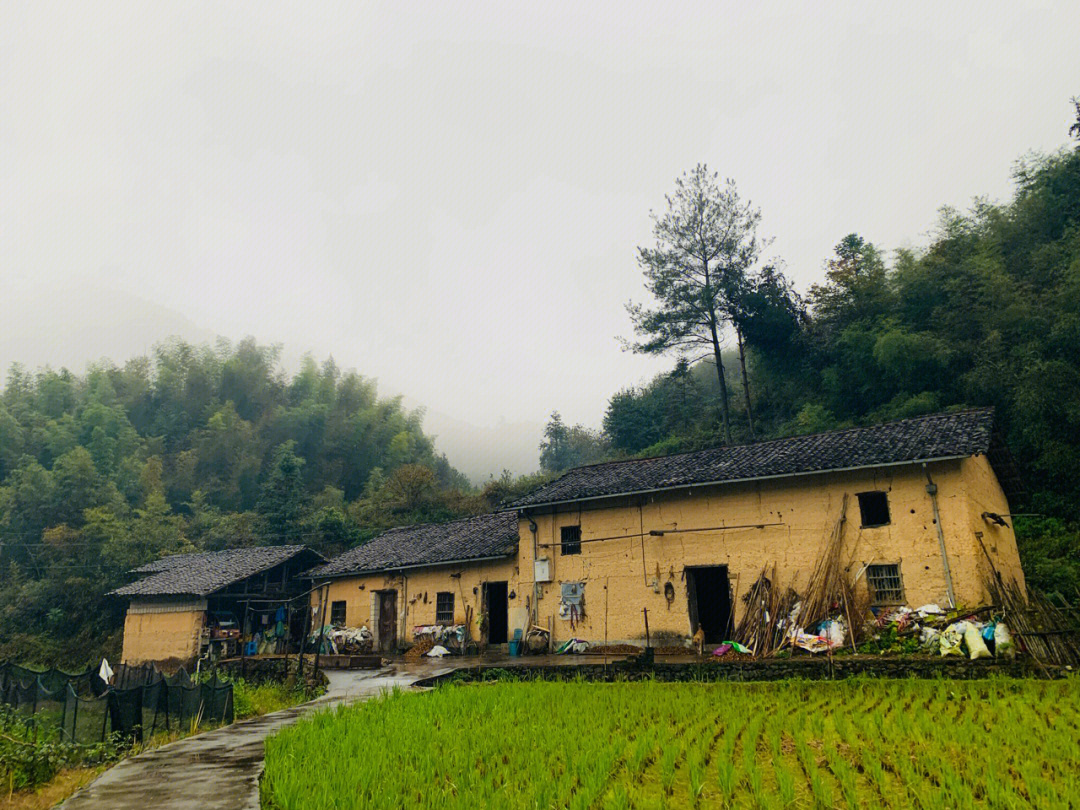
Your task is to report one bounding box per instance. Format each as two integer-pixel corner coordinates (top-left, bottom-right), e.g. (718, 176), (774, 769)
(510, 408), (994, 509)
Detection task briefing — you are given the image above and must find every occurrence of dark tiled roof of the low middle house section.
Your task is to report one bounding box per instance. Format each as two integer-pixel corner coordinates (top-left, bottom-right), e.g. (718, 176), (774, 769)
(308, 512), (517, 578)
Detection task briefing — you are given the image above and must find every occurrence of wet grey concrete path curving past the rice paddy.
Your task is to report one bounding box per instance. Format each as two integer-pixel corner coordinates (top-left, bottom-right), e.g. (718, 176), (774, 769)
(59, 664), (455, 810)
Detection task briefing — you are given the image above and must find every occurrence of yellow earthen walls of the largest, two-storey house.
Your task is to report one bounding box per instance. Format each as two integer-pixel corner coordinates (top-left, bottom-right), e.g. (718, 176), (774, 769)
(518, 458), (1022, 644)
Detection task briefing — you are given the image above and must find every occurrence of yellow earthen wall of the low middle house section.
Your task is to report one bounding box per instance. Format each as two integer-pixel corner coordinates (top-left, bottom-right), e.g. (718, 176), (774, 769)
(311, 557), (528, 643)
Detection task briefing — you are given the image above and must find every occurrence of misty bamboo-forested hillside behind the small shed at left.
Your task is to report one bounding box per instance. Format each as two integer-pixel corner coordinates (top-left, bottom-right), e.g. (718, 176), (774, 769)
(0, 340), (537, 664)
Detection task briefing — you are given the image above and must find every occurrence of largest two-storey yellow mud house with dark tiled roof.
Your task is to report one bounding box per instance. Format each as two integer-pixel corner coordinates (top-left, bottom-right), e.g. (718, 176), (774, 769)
(513, 409), (1024, 644)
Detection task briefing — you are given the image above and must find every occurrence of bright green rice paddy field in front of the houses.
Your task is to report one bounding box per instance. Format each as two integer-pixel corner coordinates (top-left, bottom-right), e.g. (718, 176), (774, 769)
(262, 678), (1080, 810)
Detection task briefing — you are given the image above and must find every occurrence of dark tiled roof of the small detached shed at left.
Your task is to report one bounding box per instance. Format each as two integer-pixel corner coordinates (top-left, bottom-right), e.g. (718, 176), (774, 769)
(111, 545), (323, 596)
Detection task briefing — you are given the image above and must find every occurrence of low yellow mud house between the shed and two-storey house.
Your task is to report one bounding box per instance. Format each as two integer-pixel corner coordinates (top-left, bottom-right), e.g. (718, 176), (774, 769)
(308, 512), (528, 651)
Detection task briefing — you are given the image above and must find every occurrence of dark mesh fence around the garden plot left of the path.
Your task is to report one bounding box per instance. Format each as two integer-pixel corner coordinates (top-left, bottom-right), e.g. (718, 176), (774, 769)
(0, 662), (232, 745)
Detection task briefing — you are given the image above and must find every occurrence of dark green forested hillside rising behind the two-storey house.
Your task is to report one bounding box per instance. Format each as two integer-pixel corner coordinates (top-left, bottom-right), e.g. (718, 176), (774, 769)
(541, 145), (1080, 598)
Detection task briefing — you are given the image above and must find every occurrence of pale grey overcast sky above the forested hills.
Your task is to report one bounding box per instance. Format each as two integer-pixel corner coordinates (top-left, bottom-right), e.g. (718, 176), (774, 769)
(0, 0), (1080, 461)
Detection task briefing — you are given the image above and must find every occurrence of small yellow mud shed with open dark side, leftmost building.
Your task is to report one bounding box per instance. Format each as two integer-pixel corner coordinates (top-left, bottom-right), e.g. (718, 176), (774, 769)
(111, 545), (325, 665)
